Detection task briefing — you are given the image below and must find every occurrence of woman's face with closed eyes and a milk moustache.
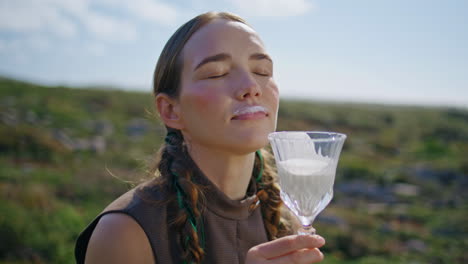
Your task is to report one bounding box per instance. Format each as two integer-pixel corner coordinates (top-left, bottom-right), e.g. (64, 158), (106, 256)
(177, 19), (279, 154)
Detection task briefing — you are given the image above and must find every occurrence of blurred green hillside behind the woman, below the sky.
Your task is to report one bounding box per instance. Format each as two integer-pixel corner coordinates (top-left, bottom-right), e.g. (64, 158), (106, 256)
(0, 78), (468, 264)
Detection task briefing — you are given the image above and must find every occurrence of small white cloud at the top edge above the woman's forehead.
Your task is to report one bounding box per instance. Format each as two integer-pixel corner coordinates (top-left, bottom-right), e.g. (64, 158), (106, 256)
(229, 0), (313, 17)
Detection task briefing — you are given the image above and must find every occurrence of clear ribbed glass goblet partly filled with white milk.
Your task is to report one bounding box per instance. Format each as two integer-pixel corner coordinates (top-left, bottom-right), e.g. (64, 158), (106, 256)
(268, 131), (346, 234)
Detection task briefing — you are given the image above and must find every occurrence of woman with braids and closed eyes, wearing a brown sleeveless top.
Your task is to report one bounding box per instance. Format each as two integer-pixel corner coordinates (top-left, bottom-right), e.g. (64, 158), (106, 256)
(75, 12), (325, 263)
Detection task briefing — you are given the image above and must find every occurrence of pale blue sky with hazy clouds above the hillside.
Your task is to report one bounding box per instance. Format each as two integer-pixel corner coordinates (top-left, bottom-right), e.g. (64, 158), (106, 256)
(0, 0), (468, 108)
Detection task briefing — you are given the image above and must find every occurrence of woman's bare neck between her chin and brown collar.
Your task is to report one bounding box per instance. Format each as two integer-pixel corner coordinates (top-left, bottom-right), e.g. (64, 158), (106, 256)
(189, 145), (255, 200)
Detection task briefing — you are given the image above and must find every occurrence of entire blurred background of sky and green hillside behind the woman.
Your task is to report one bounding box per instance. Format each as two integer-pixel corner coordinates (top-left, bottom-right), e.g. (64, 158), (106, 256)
(0, 0), (468, 264)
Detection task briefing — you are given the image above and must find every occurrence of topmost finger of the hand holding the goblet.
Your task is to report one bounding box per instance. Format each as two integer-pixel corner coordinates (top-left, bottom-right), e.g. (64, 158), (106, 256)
(257, 235), (325, 259)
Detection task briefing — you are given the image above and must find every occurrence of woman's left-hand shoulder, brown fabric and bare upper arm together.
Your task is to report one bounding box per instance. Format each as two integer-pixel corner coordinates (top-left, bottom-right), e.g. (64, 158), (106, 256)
(80, 180), (167, 263)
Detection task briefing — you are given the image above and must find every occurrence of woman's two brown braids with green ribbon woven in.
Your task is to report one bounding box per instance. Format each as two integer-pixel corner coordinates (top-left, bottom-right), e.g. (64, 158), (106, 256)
(152, 129), (291, 263)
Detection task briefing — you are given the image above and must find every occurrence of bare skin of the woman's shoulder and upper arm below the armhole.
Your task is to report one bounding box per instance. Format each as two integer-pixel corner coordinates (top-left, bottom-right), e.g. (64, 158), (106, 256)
(86, 213), (155, 263)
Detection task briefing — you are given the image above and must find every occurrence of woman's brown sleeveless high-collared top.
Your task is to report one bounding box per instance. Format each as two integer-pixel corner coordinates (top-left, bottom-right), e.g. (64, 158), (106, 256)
(75, 166), (268, 264)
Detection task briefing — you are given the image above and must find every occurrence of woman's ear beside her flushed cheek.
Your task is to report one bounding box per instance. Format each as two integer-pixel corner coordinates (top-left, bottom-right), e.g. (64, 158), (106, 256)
(155, 93), (183, 130)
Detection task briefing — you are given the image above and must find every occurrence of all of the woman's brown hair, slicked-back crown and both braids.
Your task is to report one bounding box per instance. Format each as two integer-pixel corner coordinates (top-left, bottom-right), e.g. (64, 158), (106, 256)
(152, 12), (289, 263)
